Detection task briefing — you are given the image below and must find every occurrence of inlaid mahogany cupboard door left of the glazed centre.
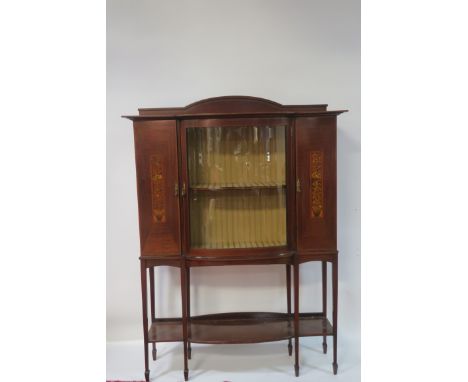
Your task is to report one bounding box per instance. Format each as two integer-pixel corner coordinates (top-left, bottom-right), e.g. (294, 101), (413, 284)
(134, 121), (180, 256)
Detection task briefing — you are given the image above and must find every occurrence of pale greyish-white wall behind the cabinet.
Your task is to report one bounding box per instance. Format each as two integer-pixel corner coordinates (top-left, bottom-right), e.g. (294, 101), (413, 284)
(107, 0), (361, 380)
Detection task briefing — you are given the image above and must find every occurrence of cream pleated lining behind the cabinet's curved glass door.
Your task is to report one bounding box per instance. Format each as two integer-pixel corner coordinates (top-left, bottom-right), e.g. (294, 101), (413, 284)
(187, 126), (286, 248)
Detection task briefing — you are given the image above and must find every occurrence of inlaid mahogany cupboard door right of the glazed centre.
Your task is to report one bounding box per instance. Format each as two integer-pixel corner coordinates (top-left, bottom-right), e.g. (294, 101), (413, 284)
(295, 116), (336, 252)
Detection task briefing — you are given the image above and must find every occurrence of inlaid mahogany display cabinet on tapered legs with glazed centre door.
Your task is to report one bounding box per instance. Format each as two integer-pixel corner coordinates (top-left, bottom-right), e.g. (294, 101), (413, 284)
(124, 96), (346, 381)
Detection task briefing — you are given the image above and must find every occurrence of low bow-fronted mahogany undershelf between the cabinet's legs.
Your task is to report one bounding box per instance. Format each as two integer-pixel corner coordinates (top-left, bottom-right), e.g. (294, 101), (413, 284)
(148, 312), (333, 344)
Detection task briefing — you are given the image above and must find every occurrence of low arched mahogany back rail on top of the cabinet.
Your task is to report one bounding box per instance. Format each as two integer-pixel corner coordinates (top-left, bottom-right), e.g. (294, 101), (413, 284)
(138, 96), (327, 115)
